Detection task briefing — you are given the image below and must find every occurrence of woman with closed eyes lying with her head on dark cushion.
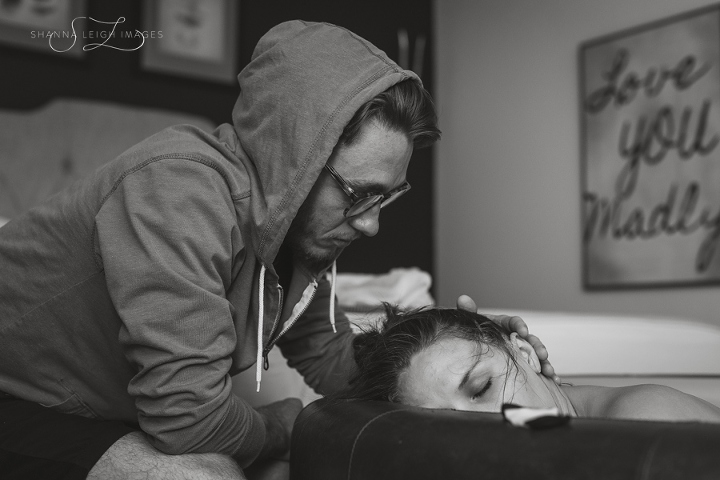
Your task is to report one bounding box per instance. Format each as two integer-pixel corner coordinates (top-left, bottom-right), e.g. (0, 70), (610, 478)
(343, 305), (720, 422)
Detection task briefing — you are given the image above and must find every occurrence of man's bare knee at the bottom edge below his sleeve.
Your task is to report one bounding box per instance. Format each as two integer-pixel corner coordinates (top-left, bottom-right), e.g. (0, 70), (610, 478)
(87, 432), (245, 480)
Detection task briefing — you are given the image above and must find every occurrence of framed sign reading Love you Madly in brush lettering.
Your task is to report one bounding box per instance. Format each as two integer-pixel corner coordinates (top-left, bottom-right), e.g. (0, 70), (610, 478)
(579, 5), (720, 289)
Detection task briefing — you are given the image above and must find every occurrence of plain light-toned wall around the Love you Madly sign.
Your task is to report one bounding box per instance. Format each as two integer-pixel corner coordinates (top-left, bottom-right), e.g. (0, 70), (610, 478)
(435, 0), (720, 325)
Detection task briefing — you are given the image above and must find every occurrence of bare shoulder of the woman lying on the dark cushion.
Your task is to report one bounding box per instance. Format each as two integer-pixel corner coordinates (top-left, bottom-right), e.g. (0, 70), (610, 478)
(571, 384), (720, 422)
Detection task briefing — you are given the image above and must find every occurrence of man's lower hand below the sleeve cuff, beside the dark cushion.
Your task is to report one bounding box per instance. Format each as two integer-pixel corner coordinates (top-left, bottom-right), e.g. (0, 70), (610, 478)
(257, 398), (303, 460)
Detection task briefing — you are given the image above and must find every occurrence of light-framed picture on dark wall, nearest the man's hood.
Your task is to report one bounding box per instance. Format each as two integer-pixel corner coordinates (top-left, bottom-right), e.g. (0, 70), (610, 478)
(142, 0), (239, 84)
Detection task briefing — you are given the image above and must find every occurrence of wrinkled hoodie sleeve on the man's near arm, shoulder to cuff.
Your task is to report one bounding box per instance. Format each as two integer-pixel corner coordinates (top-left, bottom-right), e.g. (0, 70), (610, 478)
(96, 158), (265, 465)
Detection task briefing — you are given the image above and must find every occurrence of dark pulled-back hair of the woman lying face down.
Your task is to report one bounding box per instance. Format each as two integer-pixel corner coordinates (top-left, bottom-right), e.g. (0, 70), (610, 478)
(339, 304), (515, 403)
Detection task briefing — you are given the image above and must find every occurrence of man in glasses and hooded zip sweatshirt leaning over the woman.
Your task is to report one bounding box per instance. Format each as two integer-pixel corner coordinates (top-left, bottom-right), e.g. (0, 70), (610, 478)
(0, 21), (552, 478)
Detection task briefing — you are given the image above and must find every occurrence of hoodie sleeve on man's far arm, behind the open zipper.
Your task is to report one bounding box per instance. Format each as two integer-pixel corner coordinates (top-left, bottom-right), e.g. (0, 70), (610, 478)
(277, 277), (355, 395)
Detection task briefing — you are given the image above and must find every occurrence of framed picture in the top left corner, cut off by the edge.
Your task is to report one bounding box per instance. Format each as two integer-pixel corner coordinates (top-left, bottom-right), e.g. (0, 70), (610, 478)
(0, 0), (85, 58)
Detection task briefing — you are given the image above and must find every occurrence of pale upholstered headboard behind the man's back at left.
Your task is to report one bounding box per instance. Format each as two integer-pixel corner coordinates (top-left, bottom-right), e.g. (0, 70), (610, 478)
(0, 98), (214, 222)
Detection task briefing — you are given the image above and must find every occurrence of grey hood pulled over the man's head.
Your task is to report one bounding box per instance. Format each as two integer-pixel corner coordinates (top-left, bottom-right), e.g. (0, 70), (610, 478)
(233, 20), (420, 265)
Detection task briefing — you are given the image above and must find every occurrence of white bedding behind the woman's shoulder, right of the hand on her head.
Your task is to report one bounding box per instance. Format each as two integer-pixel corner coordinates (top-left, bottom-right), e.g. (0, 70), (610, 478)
(484, 309), (720, 406)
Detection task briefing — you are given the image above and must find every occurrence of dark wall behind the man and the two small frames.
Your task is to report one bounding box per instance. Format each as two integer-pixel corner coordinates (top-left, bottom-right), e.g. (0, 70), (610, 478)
(0, 0), (434, 273)
